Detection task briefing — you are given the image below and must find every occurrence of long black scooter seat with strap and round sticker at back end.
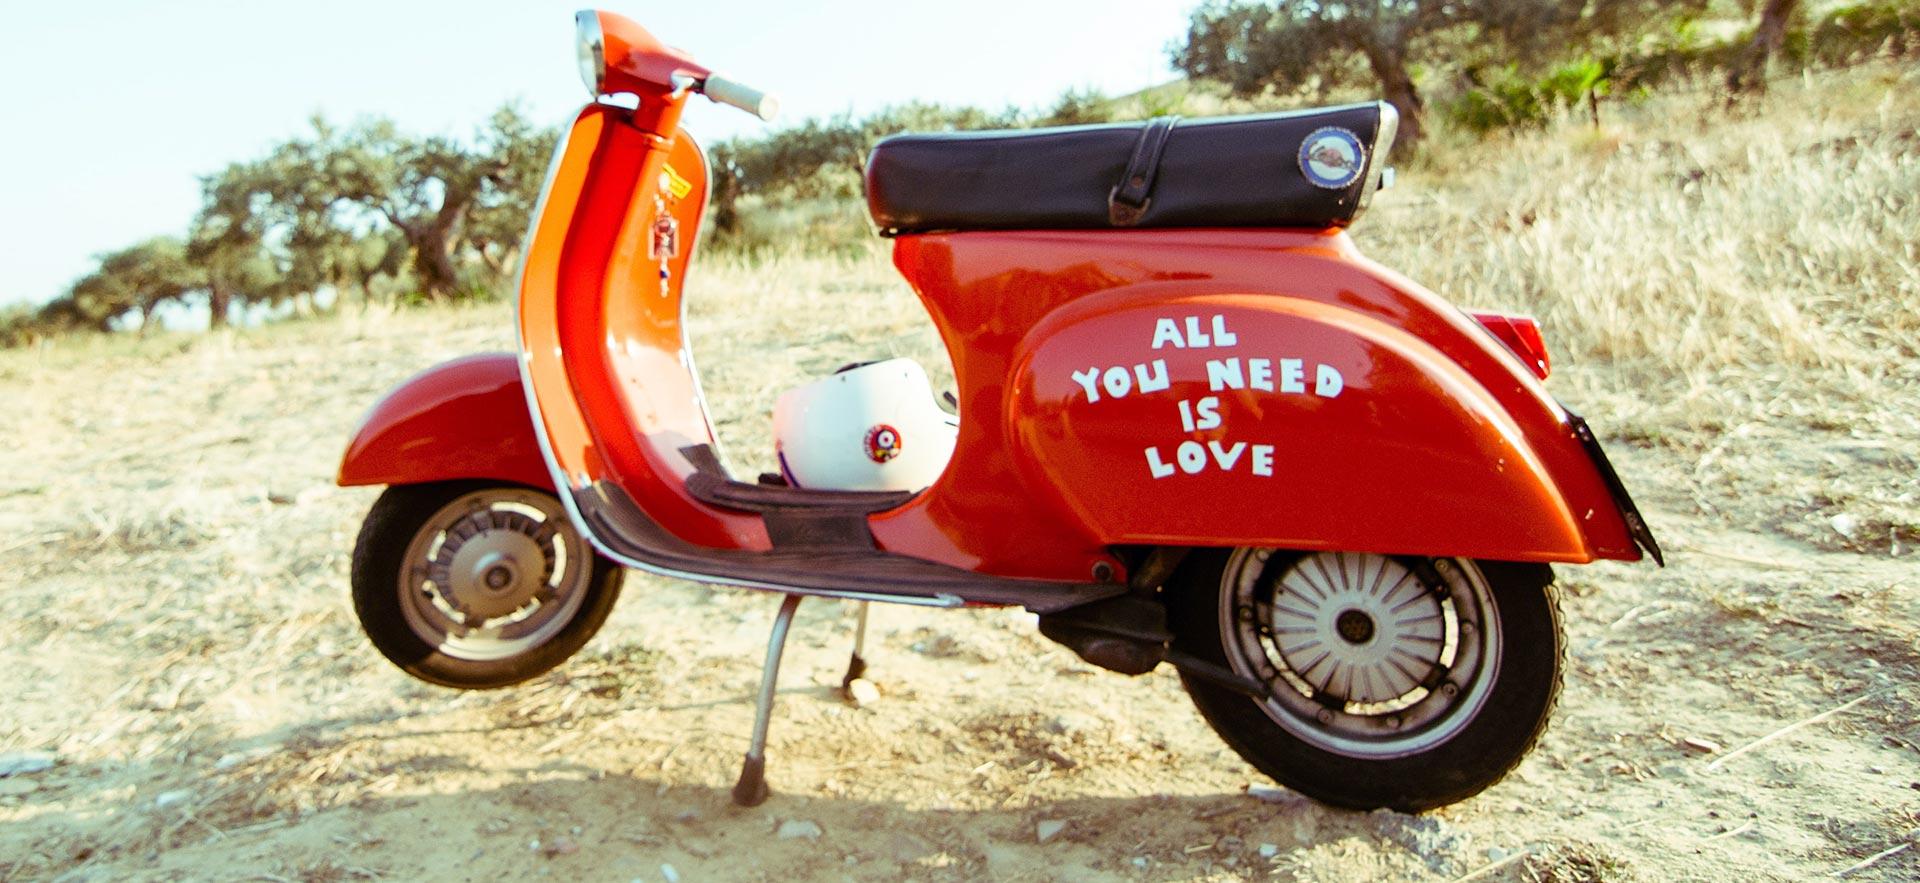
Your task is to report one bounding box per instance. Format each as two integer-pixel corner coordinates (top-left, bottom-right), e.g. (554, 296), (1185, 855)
(866, 102), (1398, 234)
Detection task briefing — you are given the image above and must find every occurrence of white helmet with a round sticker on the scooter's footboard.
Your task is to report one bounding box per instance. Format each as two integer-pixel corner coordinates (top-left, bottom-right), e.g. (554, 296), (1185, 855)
(774, 359), (960, 491)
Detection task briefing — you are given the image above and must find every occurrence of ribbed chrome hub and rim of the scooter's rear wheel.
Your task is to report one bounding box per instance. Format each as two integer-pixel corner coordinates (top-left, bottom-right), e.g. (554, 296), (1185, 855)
(1221, 549), (1500, 758)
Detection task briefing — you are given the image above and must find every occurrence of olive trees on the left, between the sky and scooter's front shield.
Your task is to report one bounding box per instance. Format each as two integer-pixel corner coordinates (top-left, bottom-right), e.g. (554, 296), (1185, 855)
(18, 106), (555, 344)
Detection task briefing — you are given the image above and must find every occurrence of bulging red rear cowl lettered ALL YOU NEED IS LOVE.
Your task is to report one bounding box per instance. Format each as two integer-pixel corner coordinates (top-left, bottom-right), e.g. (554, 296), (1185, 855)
(1008, 284), (1638, 561)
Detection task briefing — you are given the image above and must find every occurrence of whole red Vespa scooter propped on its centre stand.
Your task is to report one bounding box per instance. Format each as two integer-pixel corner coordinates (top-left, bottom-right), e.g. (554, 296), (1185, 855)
(340, 12), (1659, 810)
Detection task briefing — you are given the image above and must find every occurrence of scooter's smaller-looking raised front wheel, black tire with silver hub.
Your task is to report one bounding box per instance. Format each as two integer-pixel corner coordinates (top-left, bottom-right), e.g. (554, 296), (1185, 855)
(353, 482), (624, 689)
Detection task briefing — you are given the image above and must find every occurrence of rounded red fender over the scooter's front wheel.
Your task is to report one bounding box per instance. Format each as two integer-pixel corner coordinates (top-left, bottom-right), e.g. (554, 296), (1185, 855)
(338, 353), (553, 489)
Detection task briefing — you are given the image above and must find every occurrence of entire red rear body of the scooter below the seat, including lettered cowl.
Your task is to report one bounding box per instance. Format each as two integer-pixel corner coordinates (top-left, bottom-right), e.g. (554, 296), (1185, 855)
(874, 230), (1640, 572)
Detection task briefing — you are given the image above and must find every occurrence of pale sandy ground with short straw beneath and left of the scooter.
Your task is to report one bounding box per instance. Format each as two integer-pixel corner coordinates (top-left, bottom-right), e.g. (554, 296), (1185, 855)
(0, 284), (1920, 881)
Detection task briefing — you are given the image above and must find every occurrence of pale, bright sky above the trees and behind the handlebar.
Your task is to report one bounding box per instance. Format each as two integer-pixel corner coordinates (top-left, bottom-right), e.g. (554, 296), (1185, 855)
(0, 0), (1198, 303)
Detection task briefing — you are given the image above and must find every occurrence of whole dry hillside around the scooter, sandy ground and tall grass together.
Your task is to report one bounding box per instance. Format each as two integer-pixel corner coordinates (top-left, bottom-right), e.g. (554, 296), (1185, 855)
(0, 65), (1920, 881)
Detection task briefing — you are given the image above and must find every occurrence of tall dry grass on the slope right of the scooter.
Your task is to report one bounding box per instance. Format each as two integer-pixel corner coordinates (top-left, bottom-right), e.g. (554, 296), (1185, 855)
(1356, 65), (1920, 553)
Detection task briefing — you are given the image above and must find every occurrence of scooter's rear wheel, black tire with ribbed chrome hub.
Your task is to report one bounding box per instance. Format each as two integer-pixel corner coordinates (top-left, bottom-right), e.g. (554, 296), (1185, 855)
(1167, 549), (1563, 812)
